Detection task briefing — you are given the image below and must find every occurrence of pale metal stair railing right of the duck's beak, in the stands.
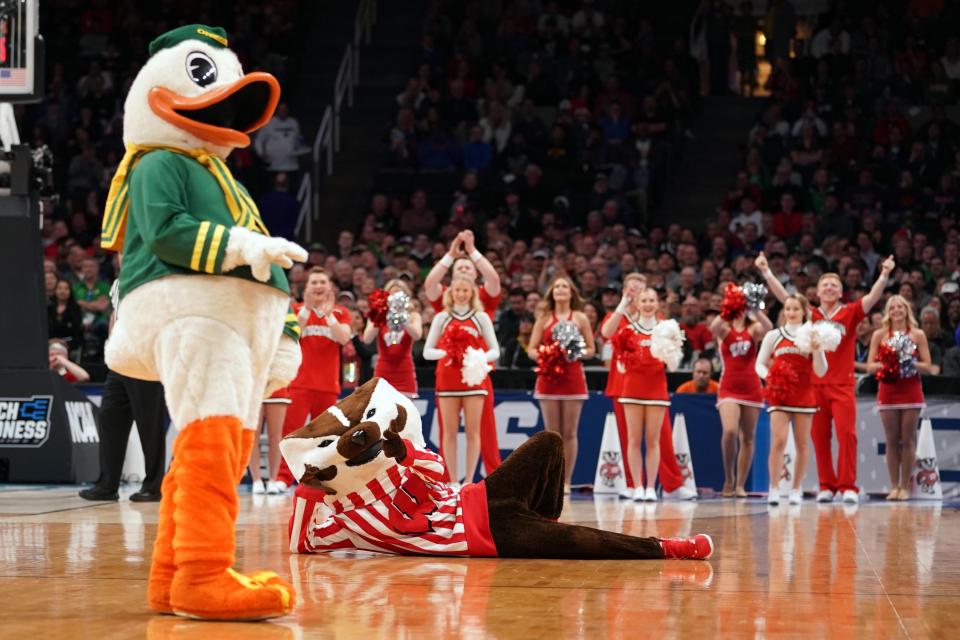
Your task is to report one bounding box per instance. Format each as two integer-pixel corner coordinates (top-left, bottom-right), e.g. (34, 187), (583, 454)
(297, 0), (377, 241)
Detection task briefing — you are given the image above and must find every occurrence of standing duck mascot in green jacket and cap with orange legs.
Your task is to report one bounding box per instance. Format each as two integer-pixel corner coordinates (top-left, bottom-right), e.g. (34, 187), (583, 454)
(101, 25), (307, 620)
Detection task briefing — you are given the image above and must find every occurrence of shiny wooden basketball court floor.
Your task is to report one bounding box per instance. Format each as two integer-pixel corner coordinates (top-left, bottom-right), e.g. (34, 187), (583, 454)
(0, 485), (960, 640)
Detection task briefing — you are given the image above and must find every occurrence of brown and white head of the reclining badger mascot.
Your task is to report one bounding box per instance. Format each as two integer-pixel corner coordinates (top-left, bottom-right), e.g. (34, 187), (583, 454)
(280, 378), (424, 496)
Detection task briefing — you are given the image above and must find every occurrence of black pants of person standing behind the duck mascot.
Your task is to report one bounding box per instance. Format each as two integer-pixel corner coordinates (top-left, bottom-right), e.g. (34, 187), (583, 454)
(97, 371), (167, 493)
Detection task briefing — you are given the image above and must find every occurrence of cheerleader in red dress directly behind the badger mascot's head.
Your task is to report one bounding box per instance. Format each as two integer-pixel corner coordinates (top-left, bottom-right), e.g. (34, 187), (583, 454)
(363, 280), (423, 398)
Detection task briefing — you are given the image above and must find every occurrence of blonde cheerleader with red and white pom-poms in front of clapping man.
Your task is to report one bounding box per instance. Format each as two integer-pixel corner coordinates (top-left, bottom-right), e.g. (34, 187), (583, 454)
(601, 282), (670, 502)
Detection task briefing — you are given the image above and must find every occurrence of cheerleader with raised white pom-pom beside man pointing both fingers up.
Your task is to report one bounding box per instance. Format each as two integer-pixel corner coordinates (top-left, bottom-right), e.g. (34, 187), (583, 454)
(756, 293), (827, 505)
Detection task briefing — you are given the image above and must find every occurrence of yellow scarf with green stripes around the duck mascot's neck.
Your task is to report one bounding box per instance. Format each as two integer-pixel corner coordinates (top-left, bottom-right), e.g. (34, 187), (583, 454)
(100, 144), (270, 251)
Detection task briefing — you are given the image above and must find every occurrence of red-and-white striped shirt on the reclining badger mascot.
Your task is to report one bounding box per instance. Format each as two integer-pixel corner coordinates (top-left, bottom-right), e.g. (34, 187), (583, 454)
(290, 440), (496, 556)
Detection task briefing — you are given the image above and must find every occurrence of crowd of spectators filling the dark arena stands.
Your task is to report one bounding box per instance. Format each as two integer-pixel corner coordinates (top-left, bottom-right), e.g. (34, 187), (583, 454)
(26, 0), (960, 377)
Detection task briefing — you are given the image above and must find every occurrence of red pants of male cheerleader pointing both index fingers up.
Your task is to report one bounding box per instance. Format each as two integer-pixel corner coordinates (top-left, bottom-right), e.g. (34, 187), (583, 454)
(810, 385), (859, 492)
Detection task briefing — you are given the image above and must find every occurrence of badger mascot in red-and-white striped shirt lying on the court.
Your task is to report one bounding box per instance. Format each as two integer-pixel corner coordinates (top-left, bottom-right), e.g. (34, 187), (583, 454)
(280, 378), (713, 560)
